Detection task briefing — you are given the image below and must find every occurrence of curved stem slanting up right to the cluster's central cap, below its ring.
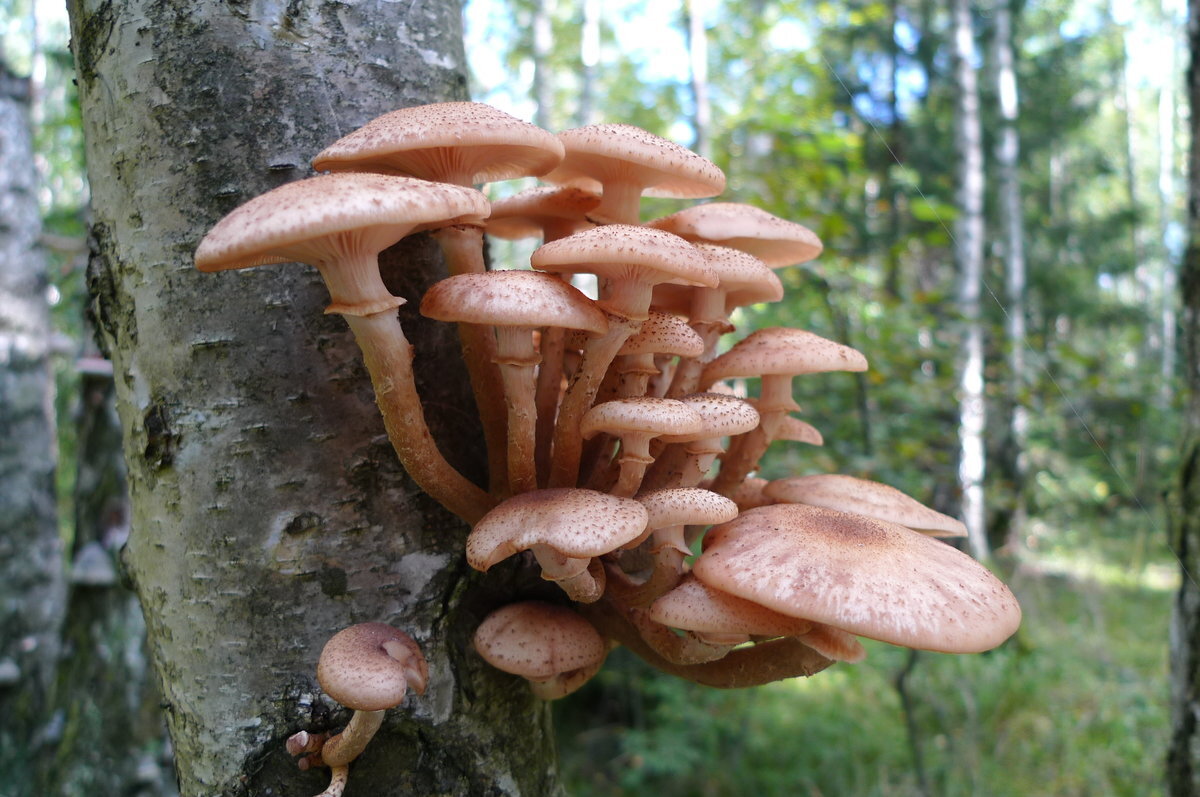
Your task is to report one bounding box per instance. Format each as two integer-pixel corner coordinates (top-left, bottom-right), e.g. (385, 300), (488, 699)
(550, 313), (641, 487)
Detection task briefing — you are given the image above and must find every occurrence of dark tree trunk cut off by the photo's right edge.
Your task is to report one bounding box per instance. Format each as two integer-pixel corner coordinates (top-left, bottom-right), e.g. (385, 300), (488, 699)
(1166, 0), (1200, 797)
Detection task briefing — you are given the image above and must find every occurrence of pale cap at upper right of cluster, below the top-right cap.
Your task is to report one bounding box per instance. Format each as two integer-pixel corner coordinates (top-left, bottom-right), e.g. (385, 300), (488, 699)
(648, 202), (823, 269)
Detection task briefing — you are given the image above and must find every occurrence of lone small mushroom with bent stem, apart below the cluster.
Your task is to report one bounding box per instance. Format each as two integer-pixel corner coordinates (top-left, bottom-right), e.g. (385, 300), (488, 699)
(289, 623), (430, 795)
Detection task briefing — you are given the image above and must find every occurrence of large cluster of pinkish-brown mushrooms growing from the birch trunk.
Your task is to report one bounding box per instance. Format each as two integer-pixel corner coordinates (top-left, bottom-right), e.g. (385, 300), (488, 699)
(196, 102), (1020, 787)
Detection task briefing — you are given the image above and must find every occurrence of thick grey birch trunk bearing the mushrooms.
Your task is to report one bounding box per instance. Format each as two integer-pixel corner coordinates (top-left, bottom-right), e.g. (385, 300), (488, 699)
(70, 0), (558, 795)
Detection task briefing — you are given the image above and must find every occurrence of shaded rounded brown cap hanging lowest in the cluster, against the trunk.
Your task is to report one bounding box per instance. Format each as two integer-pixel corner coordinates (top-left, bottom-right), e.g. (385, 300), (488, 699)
(474, 600), (608, 681)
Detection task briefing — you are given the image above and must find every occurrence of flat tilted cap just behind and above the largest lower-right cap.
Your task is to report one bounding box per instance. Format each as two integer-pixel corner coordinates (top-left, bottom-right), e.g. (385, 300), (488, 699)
(763, 473), (967, 537)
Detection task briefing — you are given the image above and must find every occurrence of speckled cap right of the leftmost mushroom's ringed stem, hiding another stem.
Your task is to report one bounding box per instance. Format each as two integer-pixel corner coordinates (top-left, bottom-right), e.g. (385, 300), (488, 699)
(421, 270), (608, 332)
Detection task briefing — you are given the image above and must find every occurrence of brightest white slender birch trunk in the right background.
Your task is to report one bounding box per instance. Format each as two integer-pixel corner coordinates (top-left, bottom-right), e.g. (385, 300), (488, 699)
(953, 0), (990, 559)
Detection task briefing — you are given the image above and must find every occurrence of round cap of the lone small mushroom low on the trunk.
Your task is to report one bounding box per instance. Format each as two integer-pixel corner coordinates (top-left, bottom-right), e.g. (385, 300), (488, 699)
(317, 623), (430, 712)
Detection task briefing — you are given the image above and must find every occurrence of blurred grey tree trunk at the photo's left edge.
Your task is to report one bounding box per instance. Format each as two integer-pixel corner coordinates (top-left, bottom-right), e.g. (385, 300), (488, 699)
(0, 53), (66, 793)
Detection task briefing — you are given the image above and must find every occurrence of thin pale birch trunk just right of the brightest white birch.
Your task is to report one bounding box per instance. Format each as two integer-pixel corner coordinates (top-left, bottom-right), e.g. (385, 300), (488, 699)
(991, 0), (1030, 545)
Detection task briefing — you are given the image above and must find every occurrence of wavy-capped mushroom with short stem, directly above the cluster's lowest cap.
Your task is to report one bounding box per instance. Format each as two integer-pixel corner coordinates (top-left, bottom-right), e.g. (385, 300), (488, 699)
(467, 487), (647, 603)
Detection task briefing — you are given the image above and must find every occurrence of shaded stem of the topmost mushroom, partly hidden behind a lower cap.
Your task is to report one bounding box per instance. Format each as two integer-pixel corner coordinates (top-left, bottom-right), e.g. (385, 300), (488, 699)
(432, 224), (508, 493)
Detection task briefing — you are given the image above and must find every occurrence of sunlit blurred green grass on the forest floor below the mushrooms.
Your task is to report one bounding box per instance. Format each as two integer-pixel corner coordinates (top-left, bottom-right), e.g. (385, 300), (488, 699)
(556, 547), (1174, 797)
